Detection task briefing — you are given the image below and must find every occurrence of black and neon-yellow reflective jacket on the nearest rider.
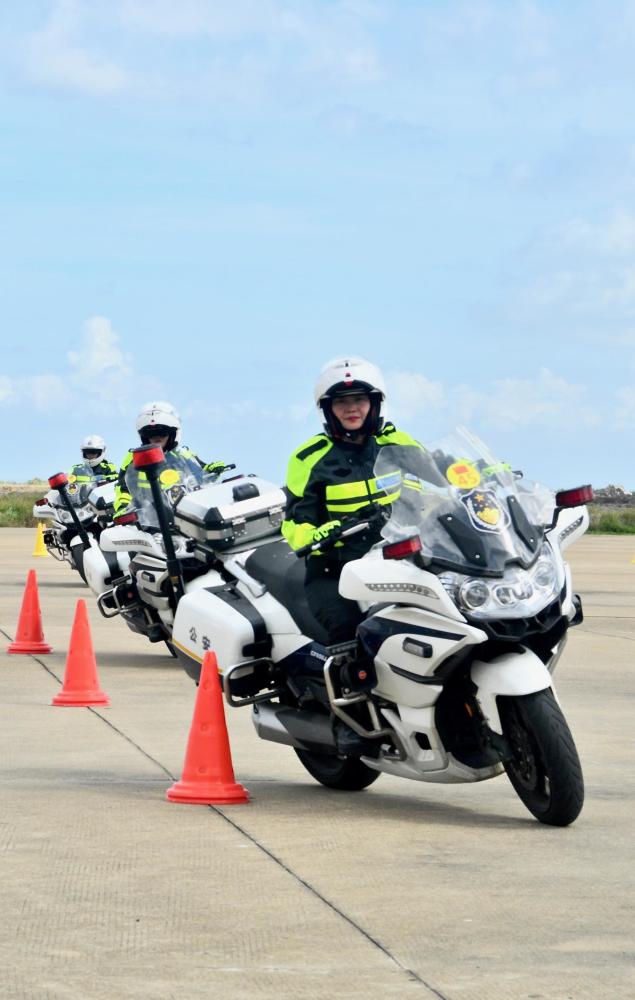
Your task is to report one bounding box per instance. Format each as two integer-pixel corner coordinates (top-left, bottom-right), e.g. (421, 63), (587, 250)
(282, 424), (425, 562)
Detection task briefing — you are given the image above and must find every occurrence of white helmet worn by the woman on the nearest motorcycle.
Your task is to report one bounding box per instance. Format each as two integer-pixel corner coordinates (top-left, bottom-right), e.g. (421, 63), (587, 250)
(315, 357), (386, 438)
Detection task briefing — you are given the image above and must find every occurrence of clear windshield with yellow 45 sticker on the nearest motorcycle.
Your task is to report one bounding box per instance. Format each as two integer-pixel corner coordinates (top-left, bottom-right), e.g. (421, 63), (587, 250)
(375, 427), (555, 576)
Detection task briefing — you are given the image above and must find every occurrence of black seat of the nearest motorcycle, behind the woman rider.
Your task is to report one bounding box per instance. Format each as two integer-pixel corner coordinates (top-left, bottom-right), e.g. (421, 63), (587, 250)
(245, 539), (329, 646)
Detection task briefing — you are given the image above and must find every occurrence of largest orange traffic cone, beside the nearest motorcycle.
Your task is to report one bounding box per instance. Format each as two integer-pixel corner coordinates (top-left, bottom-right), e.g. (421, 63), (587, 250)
(166, 653), (249, 806)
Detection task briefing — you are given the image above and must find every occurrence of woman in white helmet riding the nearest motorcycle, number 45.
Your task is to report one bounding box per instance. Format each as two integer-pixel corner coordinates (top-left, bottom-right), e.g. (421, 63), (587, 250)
(282, 357), (425, 752)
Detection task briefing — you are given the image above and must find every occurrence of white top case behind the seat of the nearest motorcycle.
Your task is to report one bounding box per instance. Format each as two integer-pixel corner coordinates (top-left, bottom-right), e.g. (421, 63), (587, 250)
(174, 476), (286, 551)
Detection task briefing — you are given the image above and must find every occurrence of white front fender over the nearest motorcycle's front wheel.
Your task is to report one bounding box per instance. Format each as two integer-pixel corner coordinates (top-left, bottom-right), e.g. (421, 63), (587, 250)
(471, 649), (551, 735)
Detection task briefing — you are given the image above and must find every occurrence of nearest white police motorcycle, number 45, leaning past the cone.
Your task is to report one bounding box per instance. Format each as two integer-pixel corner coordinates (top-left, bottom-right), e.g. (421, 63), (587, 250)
(158, 429), (593, 826)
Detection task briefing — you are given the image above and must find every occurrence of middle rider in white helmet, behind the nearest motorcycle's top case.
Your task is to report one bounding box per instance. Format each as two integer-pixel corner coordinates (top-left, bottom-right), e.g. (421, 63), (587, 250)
(115, 400), (225, 517)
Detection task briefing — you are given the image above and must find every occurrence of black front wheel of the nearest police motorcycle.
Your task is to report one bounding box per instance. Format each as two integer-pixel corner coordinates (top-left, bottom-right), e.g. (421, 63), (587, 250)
(498, 690), (584, 826)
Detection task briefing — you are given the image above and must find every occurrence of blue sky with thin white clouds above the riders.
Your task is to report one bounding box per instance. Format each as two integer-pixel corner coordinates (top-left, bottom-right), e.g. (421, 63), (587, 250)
(0, 0), (635, 489)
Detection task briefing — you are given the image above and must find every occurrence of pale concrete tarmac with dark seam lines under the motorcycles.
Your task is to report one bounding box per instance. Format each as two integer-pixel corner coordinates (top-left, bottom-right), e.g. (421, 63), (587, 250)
(0, 528), (635, 1000)
